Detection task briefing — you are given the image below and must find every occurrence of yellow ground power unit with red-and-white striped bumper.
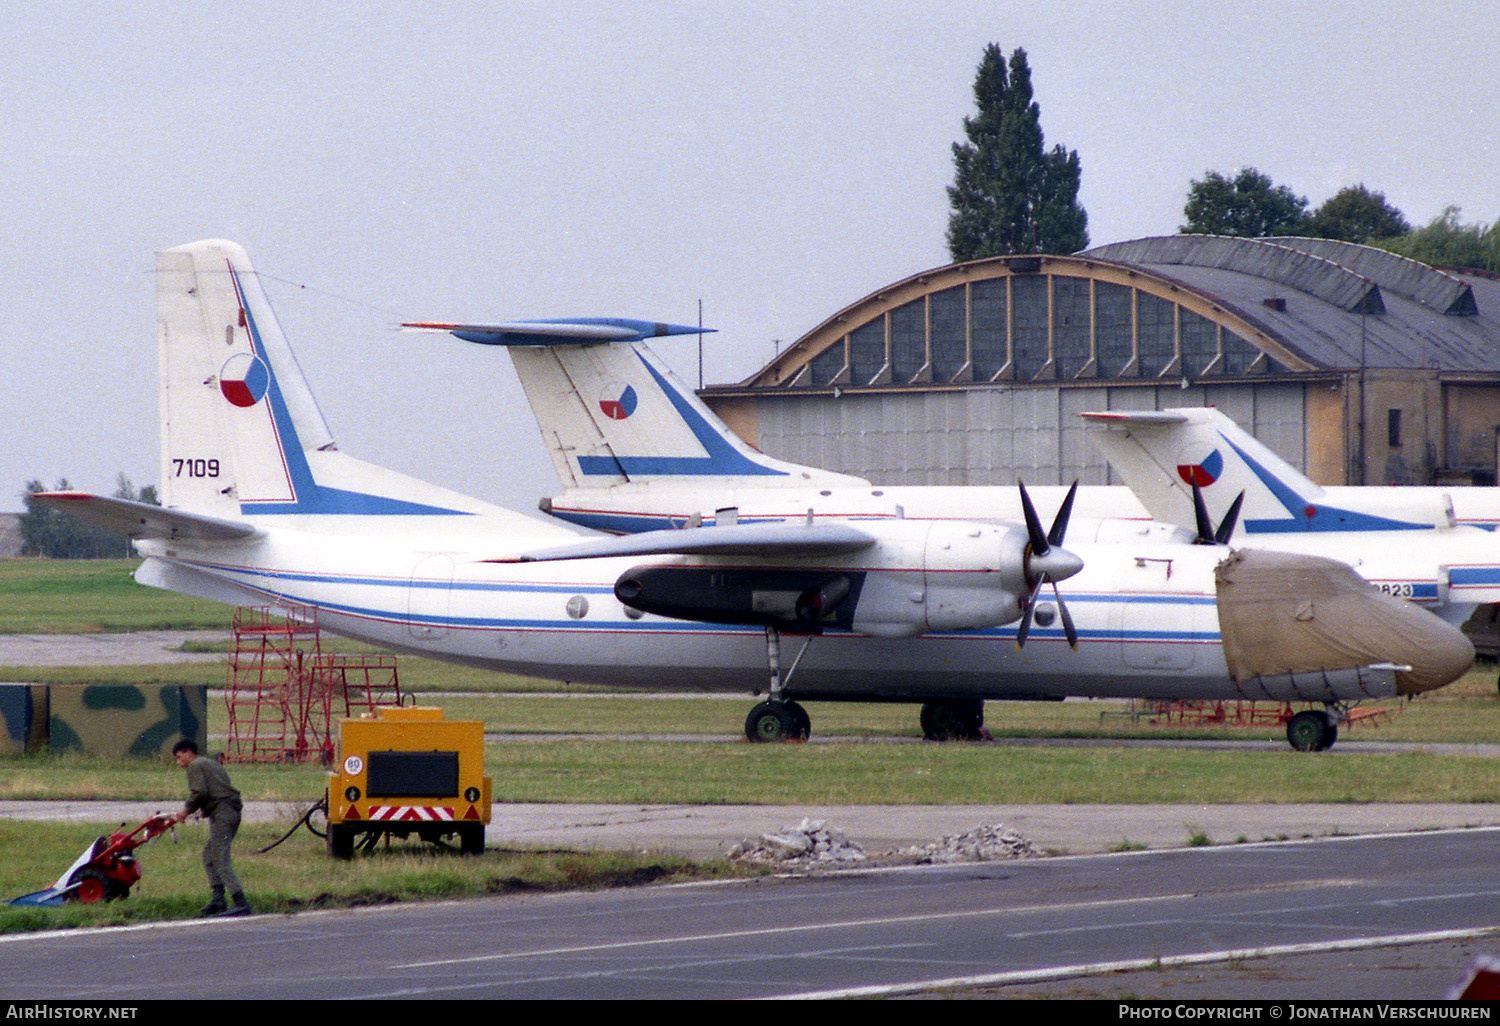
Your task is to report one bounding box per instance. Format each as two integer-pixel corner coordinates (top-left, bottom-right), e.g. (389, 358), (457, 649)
(329, 707), (491, 858)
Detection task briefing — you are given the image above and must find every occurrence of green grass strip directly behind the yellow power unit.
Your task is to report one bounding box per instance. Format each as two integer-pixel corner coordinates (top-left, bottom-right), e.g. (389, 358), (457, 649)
(0, 738), (1500, 810)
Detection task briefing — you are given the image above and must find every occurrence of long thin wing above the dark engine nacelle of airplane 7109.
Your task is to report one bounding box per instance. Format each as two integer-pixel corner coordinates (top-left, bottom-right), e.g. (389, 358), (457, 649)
(491, 522), (876, 563)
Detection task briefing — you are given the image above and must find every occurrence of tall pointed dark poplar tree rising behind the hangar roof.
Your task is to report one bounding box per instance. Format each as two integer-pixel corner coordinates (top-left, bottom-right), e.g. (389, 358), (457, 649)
(948, 44), (1089, 261)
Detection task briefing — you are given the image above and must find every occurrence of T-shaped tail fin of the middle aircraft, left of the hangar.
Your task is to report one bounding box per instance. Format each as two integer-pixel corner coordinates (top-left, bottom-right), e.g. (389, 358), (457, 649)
(405, 318), (867, 489)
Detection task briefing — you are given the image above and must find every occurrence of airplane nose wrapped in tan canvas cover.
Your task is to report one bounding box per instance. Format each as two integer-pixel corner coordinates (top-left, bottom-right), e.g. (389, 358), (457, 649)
(1217, 549), (1475, 698)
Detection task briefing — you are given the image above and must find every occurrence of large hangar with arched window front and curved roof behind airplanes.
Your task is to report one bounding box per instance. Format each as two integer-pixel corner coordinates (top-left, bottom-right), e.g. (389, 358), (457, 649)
(701, 236), (1500, 485)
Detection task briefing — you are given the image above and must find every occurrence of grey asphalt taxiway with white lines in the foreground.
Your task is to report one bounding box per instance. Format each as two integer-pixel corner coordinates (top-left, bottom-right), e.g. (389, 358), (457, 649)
(0, 830), (1500, 996)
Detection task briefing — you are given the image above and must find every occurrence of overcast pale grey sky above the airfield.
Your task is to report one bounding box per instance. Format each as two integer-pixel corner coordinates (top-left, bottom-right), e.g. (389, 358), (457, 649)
(0, 0), (1500, 510)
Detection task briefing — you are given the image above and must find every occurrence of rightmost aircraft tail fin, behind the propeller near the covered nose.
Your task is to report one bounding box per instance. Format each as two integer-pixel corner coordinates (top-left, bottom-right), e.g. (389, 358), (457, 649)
(1083, 408), (1452, 534)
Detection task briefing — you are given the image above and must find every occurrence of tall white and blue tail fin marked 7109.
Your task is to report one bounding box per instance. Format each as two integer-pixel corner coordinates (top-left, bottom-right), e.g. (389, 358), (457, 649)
(158, 240), (513, 522)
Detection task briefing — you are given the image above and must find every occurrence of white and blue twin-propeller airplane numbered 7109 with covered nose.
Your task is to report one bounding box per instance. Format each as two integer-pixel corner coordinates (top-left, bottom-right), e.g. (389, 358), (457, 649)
(39, 240), (1473, 747)
